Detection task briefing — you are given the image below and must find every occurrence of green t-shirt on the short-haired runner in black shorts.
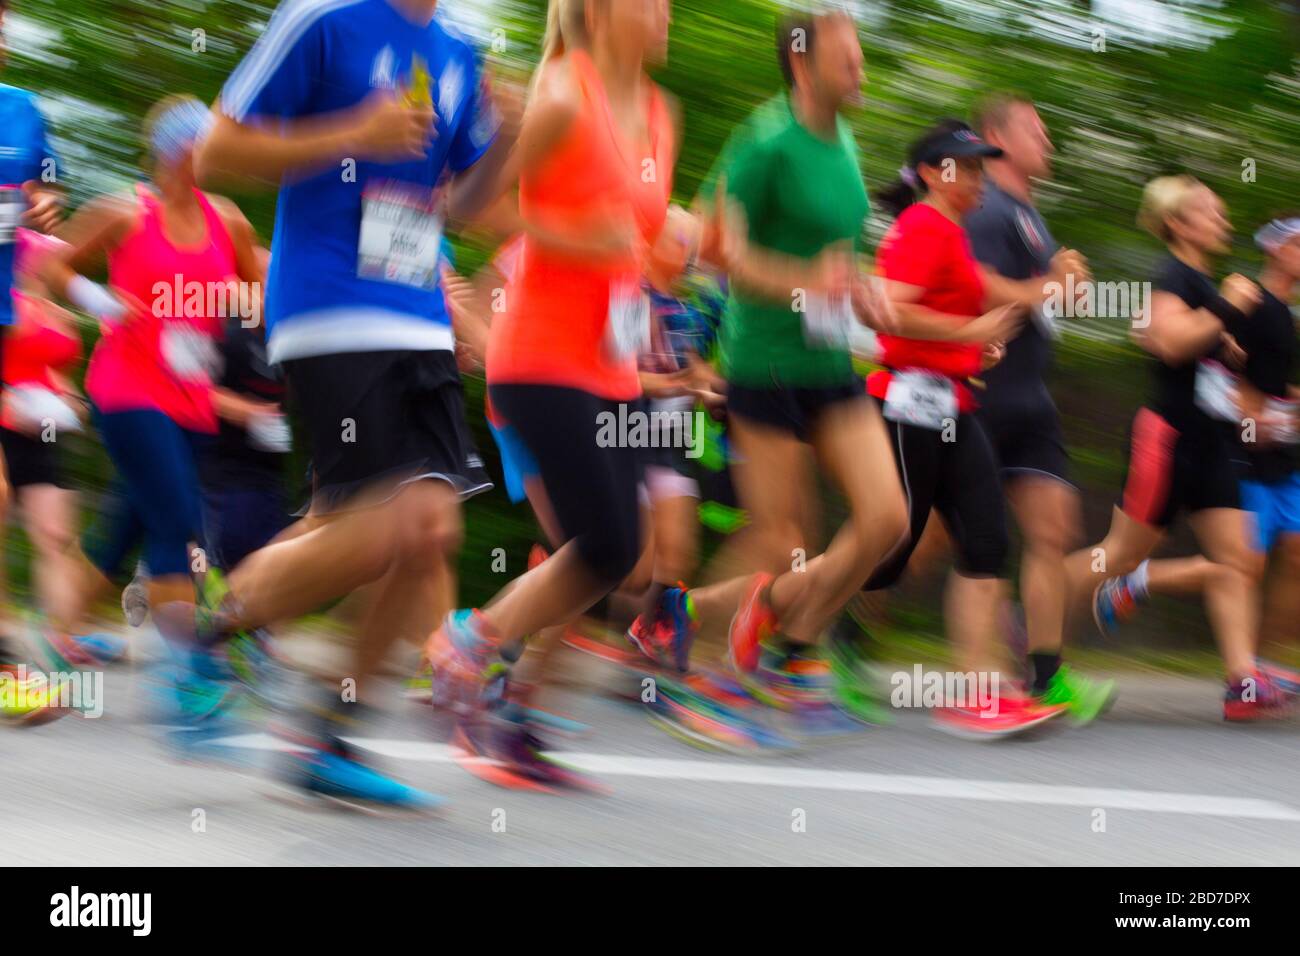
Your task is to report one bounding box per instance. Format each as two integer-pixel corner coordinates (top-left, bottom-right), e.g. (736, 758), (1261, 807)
(710, 92), (870, 388)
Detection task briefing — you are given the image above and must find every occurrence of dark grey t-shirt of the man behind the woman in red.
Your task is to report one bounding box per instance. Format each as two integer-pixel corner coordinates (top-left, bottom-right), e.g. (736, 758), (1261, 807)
(965, 182), (1057, 406)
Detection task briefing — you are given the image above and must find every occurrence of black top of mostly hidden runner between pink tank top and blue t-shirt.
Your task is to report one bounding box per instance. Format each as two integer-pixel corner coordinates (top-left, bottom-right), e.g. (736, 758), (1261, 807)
(199, 316), (285, 492)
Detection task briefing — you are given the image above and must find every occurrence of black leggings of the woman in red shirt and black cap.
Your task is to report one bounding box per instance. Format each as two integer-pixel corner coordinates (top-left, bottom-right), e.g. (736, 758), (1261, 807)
(862, 405), (1010, 591)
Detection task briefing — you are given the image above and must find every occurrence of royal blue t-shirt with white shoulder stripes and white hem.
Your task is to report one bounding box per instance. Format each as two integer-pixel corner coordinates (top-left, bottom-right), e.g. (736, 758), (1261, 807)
(221, 0), (498, 362)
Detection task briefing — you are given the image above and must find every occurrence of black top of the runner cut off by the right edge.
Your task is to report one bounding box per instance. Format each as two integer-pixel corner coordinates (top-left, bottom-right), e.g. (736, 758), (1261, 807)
(1238, 289), (1300, 481)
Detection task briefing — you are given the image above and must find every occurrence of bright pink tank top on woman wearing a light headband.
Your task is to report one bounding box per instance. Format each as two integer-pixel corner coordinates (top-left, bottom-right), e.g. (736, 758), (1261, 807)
(86, 185), (239, 432)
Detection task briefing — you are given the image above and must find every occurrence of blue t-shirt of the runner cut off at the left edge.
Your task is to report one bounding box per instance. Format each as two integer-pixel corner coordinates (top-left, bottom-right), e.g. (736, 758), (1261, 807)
(0, 85), (59, 325)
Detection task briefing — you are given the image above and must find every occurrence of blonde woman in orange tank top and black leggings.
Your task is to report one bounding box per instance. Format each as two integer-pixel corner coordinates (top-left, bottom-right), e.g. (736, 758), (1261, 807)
(429, 0), (677, 784)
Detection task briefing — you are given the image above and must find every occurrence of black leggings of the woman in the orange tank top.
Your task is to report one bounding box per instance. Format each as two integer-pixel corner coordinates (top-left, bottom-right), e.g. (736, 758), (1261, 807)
(489, 385), (644, 588)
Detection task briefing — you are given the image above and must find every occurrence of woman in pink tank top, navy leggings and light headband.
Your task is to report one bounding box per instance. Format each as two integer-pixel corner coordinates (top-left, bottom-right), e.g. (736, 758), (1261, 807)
(42, 96), (263, 650)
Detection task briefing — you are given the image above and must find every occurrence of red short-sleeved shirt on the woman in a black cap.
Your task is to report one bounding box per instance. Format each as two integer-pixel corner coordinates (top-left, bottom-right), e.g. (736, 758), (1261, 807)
(867, 203), (984, 411)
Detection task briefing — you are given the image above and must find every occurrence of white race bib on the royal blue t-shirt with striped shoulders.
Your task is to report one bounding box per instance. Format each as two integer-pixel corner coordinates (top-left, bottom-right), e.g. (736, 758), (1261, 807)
(356, 182), (443, 289)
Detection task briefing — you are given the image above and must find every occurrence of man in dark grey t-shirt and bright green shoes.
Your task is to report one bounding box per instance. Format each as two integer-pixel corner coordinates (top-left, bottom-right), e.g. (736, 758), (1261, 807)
(965, 94), (1114, 723)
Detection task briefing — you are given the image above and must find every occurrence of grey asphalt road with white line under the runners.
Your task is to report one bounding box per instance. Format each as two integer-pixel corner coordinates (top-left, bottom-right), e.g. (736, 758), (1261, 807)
(0, 642), (1300, 865)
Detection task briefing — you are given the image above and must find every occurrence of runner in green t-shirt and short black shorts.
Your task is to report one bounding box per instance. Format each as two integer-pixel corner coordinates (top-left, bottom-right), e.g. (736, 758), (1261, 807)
(632, 12), (906, 735)
